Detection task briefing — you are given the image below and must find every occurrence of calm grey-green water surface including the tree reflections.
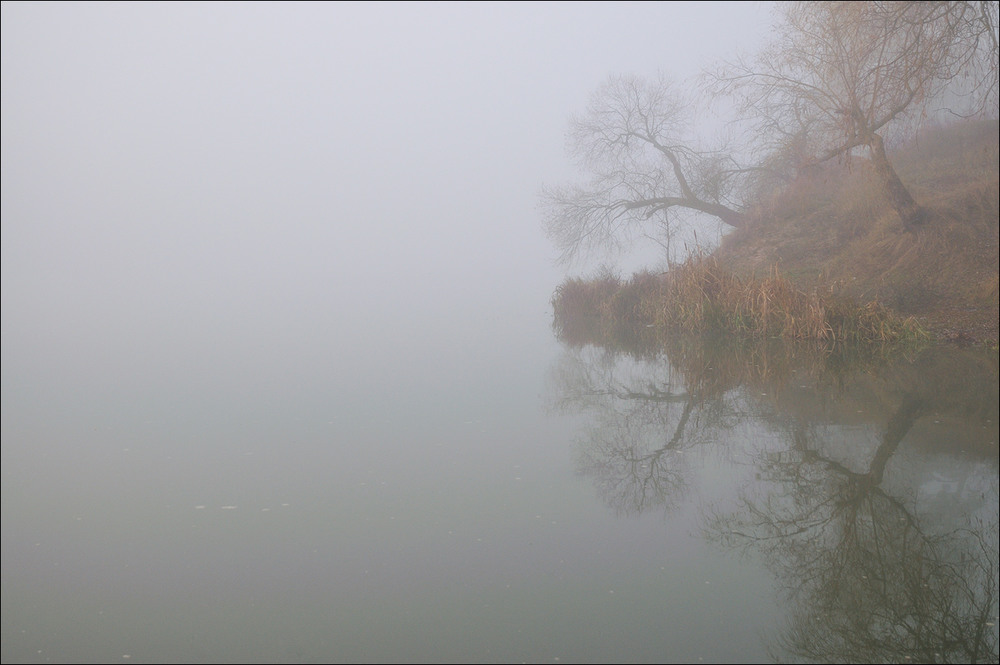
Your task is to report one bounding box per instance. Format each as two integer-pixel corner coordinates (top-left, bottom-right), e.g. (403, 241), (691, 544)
(2, 292), (998, 663)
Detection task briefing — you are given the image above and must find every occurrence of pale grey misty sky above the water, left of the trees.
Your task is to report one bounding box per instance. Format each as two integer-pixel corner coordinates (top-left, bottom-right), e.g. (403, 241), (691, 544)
(2, 2), (770, 390)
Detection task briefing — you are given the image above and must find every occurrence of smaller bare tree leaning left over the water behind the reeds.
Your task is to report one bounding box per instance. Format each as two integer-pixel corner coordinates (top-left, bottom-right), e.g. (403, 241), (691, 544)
(542, 76), (746, 263)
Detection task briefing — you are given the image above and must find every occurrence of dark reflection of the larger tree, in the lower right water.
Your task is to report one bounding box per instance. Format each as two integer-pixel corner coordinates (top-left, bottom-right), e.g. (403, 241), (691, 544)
(706, 418), (997, 663)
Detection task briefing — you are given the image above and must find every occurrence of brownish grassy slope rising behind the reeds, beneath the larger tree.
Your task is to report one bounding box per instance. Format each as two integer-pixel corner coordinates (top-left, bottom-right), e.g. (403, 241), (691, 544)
(715, 120), (1000, 344)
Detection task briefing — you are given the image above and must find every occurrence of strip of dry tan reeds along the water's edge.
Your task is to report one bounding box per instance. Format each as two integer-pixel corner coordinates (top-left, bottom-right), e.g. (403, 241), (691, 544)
(552, 256), (922, 345)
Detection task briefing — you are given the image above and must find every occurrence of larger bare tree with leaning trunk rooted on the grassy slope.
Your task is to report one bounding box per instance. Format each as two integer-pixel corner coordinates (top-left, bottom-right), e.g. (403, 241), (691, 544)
(714, 2), (997, 230)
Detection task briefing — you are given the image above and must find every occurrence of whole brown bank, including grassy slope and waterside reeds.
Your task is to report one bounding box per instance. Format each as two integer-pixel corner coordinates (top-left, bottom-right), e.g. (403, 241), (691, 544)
(553, 120), (1000, 348)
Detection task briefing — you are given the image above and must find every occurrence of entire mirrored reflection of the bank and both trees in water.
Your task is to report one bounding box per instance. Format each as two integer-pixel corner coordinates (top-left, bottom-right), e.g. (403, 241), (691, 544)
(551, 330), (1000, 663)
